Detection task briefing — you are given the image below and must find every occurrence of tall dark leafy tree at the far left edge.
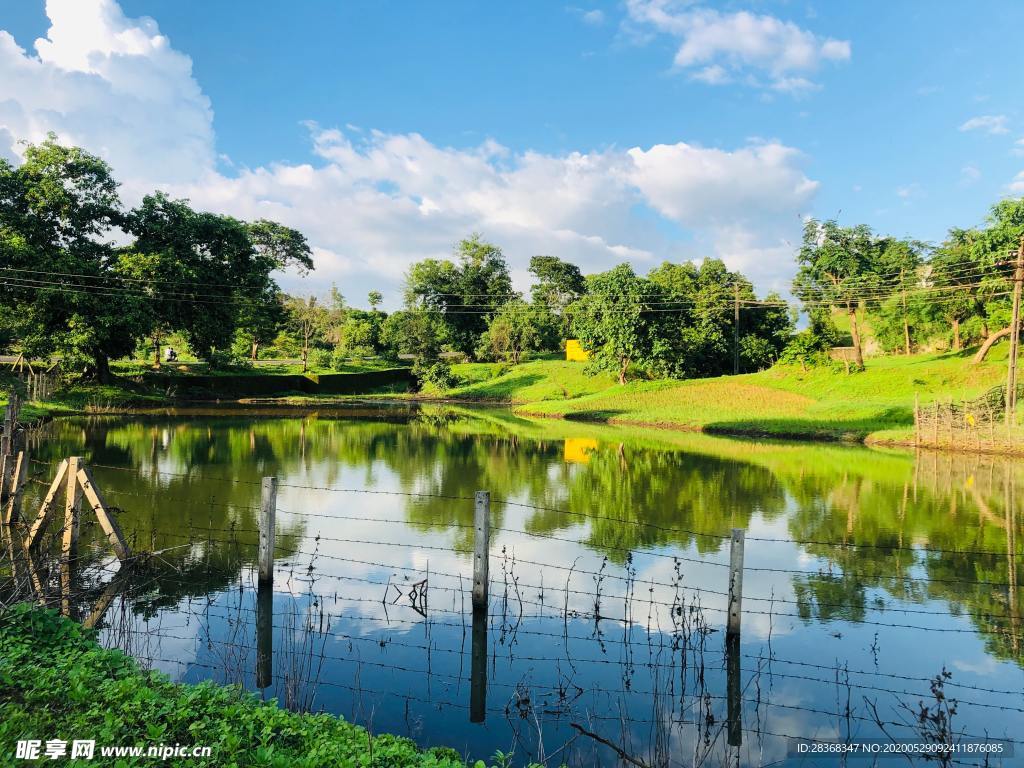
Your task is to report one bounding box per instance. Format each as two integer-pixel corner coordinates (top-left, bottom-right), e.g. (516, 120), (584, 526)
(0, 135), (145, 381)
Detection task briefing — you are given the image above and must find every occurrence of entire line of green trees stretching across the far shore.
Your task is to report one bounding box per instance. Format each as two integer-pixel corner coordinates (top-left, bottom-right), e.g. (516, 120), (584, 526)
(0, 135), (1024, 385)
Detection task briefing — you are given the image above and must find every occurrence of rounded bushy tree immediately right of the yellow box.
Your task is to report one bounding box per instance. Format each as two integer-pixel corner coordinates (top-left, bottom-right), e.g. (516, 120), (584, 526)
(569, 264), (660, 384)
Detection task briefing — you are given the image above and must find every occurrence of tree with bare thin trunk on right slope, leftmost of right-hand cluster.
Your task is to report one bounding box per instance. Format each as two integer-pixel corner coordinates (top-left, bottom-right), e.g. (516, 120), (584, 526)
(793, 219), (879, 368)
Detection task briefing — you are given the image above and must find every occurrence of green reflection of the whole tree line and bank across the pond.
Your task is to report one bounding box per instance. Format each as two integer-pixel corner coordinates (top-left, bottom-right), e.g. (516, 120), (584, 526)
(28, 408), (1024, 659)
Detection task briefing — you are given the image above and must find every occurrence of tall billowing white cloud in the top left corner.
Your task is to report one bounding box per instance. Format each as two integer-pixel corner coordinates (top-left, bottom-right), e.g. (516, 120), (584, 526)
(0, 0), (214, 193)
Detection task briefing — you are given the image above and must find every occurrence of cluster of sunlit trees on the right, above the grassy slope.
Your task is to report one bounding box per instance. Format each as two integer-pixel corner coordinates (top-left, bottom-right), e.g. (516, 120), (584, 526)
(790, 199), (1024, 367)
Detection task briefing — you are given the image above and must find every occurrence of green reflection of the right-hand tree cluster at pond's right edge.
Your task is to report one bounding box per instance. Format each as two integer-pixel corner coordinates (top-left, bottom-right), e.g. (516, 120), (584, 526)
(787, 454), (1024, 662)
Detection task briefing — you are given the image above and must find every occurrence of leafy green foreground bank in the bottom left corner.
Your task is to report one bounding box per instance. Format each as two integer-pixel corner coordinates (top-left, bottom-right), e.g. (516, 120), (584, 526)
(0, 605), (528, 768)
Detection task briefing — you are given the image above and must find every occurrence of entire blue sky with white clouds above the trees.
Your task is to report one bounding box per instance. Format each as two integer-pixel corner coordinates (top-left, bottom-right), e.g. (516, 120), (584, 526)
(0, 0), (1024, 304)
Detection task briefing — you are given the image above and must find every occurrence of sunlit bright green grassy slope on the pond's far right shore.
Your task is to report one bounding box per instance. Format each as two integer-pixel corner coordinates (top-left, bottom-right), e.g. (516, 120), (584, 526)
(423, 346), (1007, 442)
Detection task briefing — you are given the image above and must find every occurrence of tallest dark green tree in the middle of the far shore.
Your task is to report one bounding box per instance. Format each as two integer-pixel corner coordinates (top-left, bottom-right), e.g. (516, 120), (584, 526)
(406, 233), (514, 356)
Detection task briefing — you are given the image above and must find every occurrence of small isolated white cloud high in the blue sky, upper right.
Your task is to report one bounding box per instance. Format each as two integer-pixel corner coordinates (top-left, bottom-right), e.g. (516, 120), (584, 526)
(627, 0), (850, 92)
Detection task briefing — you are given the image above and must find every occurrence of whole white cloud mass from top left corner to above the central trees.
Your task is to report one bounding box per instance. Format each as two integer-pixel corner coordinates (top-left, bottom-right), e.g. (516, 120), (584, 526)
(0, 0), (817, 305)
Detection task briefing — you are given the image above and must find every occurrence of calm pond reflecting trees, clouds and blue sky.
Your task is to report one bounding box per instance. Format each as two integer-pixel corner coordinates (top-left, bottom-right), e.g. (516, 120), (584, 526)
(9, 406), (1024, 766)
